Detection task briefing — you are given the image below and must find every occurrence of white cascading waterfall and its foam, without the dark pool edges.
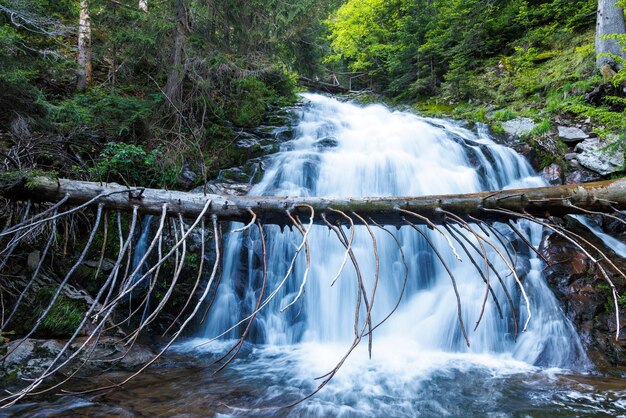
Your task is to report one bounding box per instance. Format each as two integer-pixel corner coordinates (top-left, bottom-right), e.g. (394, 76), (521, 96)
(179, 94), (589, 416)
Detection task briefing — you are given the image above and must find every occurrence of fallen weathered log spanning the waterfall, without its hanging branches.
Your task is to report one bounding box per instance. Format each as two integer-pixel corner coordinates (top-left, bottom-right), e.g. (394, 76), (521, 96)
(0, 177), (626, 226)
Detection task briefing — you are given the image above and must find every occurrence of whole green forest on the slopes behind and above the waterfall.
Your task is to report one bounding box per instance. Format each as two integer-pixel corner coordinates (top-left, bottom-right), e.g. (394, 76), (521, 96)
(0, 0), (626, 188)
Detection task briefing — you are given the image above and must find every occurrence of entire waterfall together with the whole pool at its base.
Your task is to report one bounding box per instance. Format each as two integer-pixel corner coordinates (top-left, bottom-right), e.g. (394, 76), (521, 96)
(9, 94), (626, 417)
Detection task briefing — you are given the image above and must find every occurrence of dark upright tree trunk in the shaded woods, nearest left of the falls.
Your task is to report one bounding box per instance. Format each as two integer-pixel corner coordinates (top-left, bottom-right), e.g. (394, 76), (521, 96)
(165, 0), (189, 108)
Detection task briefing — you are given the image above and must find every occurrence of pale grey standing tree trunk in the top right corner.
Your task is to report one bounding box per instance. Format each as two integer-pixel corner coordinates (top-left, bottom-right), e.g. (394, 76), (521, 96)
(596, 0), (626, 75)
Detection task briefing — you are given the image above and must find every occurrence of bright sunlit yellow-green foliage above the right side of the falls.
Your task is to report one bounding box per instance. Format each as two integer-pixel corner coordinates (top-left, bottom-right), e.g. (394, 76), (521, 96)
(327, 0), (596, 100)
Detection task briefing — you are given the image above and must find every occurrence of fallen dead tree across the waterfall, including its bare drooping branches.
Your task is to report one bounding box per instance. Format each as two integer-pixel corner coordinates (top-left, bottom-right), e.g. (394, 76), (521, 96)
(0, 177), (626, 407)
